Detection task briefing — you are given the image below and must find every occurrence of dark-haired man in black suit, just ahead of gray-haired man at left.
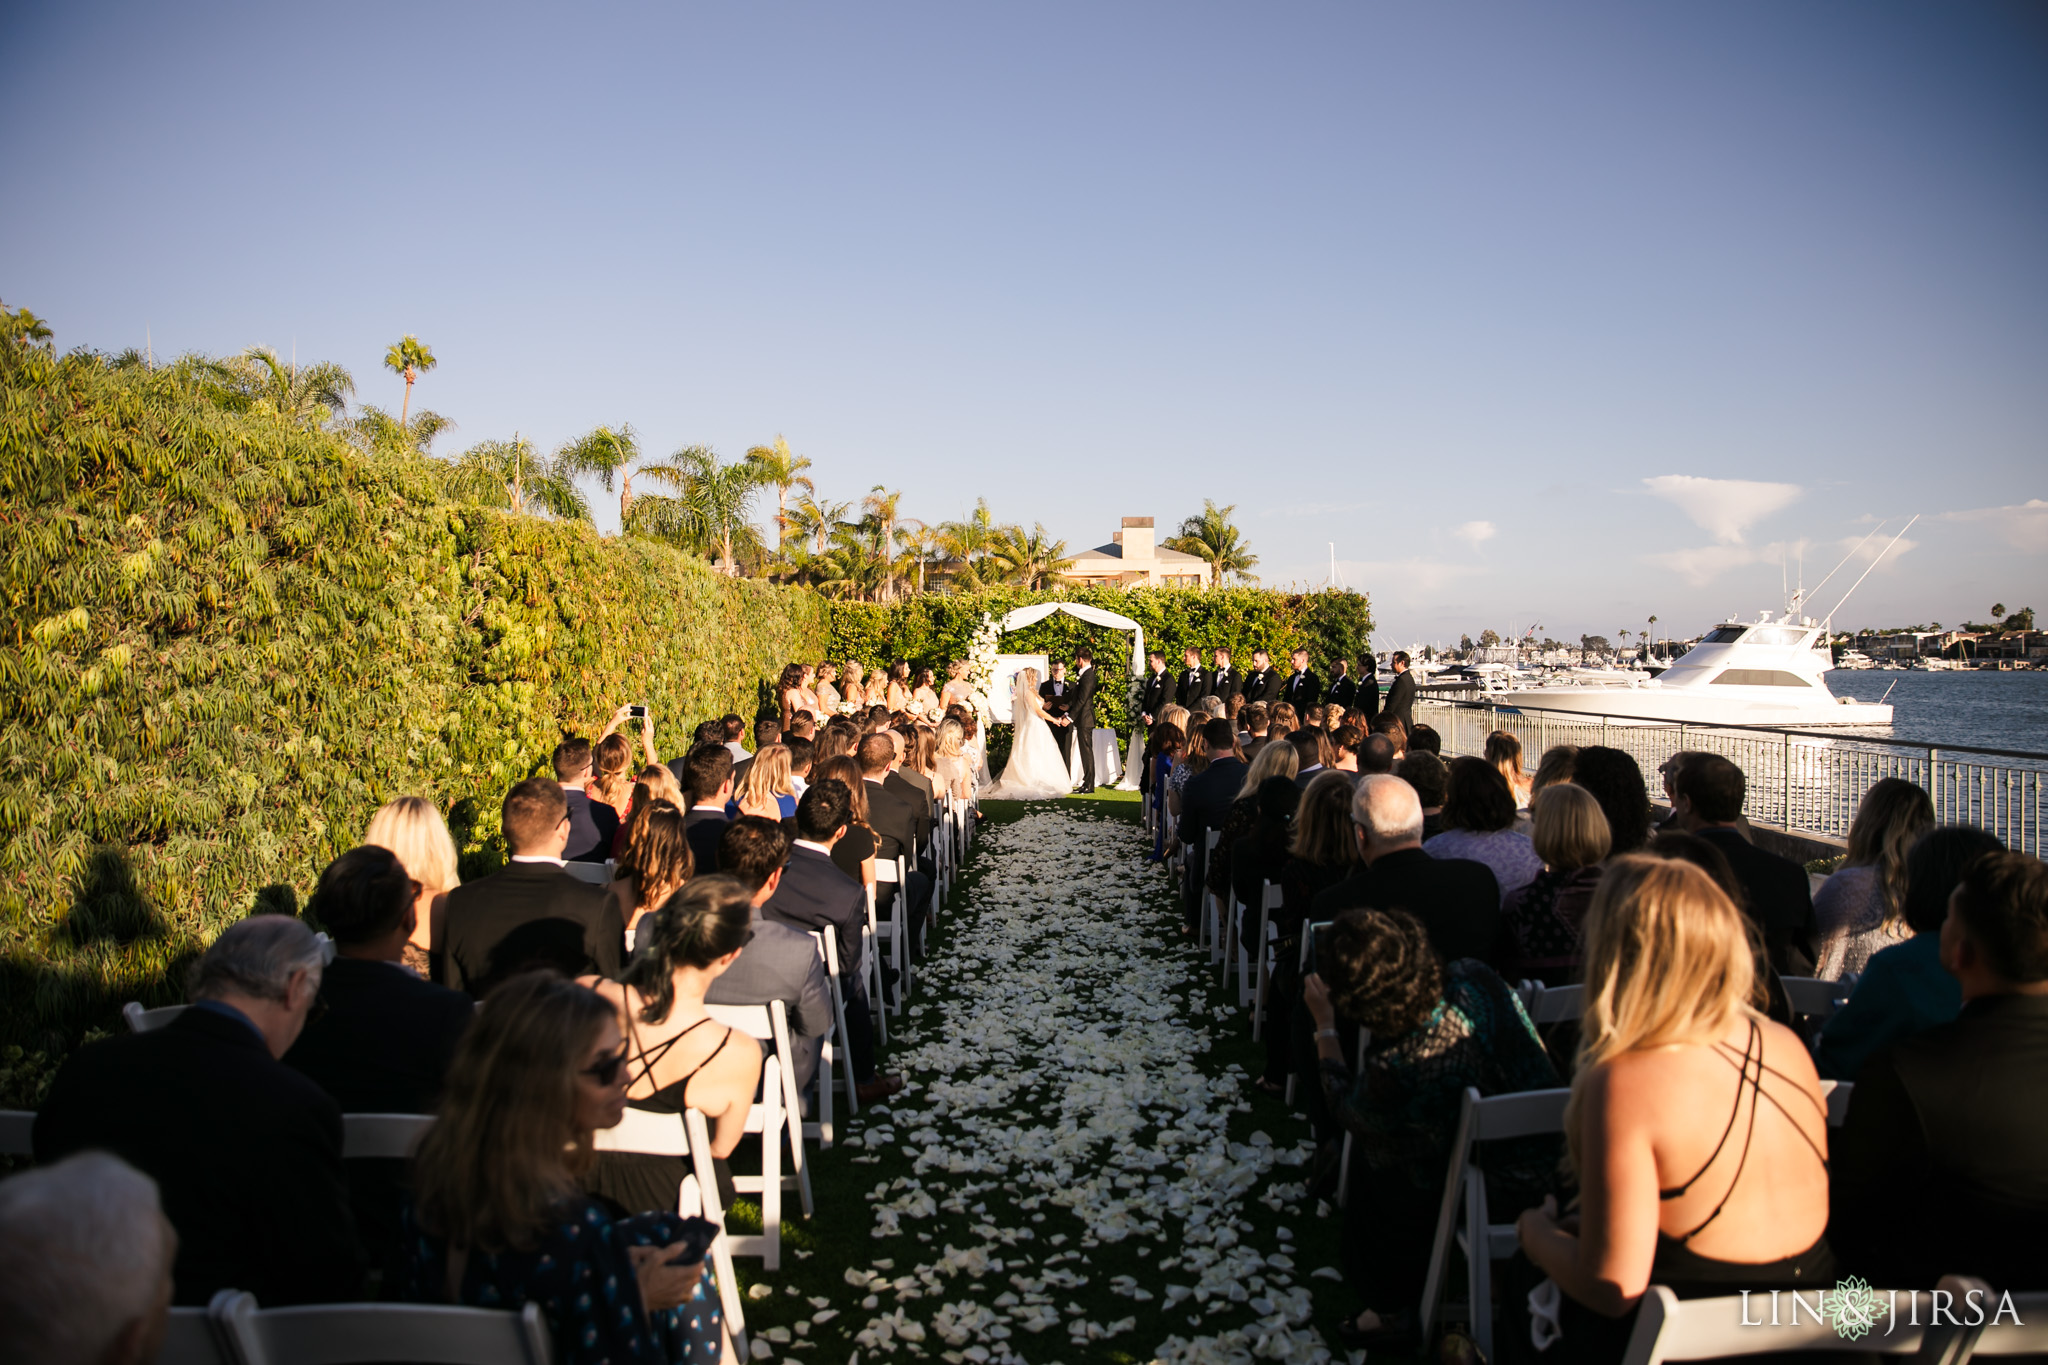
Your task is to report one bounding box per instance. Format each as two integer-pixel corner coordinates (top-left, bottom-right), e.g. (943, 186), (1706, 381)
(285, 847), (477, 1265)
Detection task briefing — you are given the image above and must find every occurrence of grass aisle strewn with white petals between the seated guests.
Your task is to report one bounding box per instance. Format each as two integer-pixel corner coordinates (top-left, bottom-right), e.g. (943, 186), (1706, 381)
(741, 802), (1346, 1365)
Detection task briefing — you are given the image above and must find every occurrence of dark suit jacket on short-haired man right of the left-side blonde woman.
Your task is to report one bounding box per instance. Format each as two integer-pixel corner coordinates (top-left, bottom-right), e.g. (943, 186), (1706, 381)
(440, 864), (627, 999)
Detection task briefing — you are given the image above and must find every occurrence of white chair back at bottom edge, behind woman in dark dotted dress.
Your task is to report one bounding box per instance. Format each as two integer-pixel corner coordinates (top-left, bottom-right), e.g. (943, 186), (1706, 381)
(219, 1293), (555, 1365)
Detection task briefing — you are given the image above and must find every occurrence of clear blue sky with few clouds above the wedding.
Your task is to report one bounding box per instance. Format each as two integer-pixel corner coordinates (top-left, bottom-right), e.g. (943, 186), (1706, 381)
(0, 2), (2048, 643)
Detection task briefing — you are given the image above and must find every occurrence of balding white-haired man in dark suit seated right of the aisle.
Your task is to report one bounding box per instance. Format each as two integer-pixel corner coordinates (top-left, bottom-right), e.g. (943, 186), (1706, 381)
(1311, 774), (1501, 962)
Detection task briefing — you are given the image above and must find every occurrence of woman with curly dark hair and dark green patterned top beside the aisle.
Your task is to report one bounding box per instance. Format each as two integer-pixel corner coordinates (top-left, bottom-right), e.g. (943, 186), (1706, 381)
(1303, 911), (1559, 1353)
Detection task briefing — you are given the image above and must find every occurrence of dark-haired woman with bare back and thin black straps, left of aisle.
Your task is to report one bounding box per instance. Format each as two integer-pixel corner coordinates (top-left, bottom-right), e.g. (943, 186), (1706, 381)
(582, 872), (762, 1214)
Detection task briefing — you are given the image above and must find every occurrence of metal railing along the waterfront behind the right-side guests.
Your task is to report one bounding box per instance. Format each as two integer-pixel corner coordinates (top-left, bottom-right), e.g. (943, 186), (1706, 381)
(1415, 694), (2048, 857)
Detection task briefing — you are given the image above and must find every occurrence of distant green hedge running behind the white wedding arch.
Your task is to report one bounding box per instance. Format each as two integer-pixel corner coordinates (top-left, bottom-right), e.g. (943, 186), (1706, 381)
(831, 587), (1372, 726)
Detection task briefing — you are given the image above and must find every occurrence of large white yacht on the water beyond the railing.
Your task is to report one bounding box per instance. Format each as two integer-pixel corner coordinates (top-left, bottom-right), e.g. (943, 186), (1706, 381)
(1505, 612), (1892, 726)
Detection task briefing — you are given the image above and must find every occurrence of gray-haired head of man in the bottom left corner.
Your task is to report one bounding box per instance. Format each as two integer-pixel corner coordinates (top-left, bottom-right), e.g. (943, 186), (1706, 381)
(0, 1152), (178, 1365)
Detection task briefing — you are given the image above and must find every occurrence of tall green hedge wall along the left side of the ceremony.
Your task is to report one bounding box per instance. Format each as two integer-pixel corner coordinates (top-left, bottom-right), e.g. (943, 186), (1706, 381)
(0, 346), (829, 1064)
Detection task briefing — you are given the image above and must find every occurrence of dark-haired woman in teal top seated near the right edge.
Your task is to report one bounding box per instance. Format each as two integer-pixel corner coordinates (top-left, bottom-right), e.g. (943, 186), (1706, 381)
(1815, 825), (2005, 1081)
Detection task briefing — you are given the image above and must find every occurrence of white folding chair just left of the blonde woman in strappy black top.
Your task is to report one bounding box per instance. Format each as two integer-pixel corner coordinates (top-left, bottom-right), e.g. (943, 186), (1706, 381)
(1421, 1087), (1571, 1359)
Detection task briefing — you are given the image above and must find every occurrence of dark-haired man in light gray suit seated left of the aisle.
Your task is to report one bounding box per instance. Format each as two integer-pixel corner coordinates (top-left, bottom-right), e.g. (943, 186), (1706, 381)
(705, 814), (831, 1091)
